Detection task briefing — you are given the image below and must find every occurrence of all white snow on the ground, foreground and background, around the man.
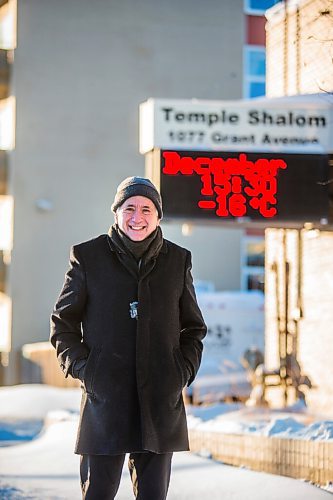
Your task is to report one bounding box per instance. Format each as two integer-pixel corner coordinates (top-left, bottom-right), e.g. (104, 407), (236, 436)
(0, 386), (331, 500)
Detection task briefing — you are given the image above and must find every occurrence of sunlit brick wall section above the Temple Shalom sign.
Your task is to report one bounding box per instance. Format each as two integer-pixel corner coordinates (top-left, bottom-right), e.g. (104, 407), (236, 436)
(266, 0), (333, 97)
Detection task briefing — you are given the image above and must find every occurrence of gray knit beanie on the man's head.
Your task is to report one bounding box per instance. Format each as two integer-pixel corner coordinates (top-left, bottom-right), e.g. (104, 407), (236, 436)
(111, 177), (163, 219)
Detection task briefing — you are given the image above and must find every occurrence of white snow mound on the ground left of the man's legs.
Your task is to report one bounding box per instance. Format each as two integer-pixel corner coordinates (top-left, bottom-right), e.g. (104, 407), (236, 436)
(0, 413), (80, 500)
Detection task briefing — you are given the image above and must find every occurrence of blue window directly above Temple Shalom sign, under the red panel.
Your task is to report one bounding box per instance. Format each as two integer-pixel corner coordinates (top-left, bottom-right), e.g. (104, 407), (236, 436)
(243, 45), (266, 99)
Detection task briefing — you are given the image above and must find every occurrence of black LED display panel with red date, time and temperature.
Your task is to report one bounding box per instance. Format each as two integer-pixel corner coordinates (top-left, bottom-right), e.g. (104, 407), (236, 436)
(157, 150), (329, 221)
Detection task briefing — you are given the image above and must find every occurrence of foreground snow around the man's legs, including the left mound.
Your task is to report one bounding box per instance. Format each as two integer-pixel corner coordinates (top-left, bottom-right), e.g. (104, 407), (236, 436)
(0, 415), (330, 500)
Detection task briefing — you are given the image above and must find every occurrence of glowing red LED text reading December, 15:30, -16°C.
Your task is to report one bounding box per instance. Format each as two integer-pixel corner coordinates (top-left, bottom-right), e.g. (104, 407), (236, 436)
(163, 151), (287, 217)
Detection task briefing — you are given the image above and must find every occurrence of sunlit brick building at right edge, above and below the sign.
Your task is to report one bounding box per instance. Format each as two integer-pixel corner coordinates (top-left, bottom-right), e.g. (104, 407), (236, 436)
(265, 0), (333, 415)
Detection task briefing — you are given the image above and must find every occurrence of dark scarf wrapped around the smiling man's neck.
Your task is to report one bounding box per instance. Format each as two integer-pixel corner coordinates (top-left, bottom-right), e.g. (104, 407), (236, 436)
(108, 224), (163, 278)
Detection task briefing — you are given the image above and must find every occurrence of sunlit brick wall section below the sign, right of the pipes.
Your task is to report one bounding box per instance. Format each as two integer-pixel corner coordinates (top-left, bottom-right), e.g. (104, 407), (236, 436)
(299, 232), (333, 413)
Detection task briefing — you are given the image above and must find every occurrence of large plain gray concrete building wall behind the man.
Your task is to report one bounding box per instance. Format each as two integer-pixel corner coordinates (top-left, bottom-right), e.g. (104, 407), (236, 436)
(6, 0), (244, 383)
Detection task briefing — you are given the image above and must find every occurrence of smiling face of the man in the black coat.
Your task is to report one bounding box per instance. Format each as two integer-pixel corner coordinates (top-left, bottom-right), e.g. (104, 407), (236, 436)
(115, 196), (160, 241)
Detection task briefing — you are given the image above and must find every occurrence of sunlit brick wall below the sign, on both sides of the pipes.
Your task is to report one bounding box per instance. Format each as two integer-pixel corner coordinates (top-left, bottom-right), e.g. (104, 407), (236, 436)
(265, 229), (333, 414)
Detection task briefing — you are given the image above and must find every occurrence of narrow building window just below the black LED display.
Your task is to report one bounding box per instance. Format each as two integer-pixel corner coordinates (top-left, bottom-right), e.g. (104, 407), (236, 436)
(241, 235), (265, 292)
